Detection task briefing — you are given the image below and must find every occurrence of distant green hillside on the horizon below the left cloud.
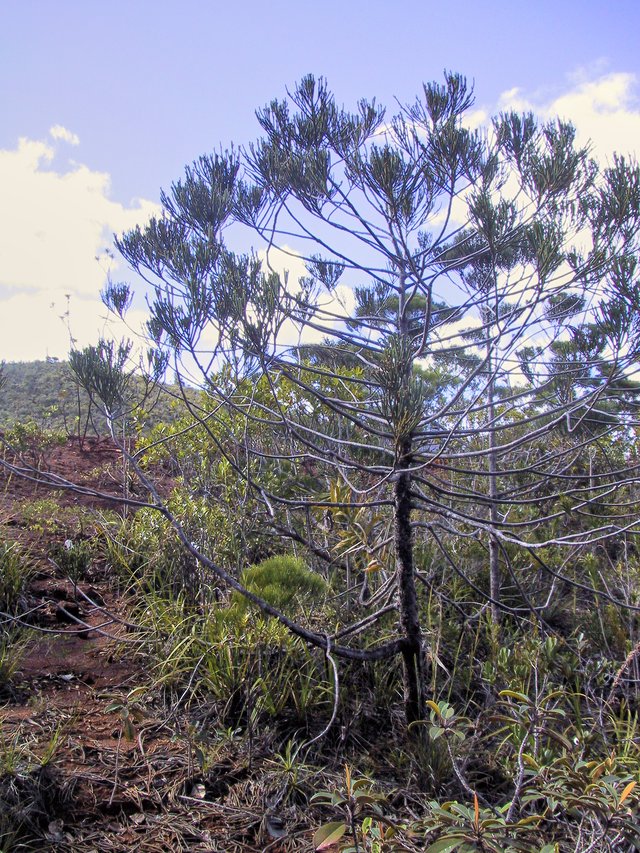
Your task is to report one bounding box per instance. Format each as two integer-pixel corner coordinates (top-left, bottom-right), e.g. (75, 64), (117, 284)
(0, 361), (191, 434)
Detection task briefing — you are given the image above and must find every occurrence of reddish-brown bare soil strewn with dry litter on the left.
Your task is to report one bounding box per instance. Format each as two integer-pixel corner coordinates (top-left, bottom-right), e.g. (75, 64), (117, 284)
(0, 440), (311, 853)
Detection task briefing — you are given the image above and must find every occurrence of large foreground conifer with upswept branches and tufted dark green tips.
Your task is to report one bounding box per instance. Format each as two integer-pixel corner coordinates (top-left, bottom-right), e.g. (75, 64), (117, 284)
(105, 74), (640, 723)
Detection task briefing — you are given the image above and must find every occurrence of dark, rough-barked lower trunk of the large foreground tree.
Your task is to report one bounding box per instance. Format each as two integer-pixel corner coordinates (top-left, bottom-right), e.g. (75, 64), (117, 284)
(394, 439), (425, 725)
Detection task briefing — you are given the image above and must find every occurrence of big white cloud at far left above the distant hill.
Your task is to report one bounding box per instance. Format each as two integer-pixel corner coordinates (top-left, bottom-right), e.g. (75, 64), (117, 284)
(0, 131), (159, 361)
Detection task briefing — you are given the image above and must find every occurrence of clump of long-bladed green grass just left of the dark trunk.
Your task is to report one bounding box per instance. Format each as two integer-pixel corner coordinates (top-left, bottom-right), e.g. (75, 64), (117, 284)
(124, 587), (332, 729)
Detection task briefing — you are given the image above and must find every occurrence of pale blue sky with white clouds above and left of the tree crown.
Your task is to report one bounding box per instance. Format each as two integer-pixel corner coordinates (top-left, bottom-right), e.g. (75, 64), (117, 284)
(0, 0), (640, 361)
